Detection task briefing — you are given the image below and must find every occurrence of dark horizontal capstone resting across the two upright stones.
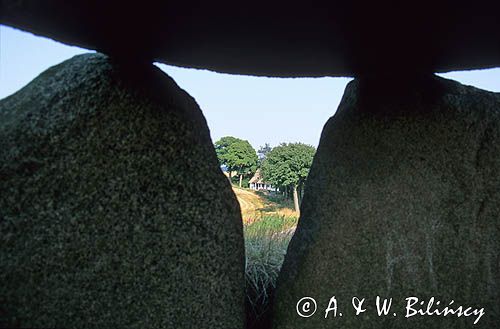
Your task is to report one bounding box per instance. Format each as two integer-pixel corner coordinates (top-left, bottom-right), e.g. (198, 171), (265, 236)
(0, 0), (500, 77)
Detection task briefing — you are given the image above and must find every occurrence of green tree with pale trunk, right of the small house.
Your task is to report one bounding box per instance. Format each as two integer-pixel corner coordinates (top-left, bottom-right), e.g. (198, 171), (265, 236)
(261, 143), (316, 213)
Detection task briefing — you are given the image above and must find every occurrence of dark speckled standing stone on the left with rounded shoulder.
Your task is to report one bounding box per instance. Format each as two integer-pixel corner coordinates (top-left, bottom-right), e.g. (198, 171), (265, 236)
(0, 54), (244, 329)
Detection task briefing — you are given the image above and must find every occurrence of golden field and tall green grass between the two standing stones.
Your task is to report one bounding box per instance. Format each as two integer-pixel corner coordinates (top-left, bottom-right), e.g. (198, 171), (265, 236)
(233, 187), (298, 329)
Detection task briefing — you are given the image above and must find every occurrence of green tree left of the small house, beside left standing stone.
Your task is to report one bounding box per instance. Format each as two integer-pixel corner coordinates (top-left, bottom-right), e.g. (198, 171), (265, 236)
(215, 136), (258, 187)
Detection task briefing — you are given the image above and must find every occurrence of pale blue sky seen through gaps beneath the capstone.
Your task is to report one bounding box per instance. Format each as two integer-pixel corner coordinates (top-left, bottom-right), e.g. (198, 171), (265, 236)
(0, 26), (500, 149)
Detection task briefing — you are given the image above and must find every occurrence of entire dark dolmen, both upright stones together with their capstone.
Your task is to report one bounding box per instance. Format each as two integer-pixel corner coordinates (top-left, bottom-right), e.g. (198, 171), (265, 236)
(0, 0), (500, 329)
